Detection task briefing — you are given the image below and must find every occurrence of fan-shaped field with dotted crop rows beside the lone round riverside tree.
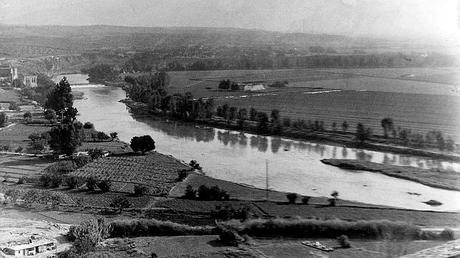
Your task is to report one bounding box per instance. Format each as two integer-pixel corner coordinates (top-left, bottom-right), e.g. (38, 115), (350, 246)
(70, 152), (189, 195)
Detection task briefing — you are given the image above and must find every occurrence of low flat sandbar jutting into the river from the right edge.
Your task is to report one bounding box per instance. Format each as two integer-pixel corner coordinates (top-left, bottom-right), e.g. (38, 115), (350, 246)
(321, 159), (460, 191)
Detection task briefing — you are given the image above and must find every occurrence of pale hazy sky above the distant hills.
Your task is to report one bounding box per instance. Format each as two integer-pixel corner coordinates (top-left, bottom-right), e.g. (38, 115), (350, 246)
(0, 0), (460, 36)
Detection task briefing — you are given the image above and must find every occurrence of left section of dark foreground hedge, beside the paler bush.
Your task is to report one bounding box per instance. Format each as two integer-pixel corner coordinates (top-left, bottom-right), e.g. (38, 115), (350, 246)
(110, 219), (216, 238)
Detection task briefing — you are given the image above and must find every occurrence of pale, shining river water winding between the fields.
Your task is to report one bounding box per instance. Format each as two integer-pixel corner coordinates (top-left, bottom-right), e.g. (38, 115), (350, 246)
(63, 74), (460, 211)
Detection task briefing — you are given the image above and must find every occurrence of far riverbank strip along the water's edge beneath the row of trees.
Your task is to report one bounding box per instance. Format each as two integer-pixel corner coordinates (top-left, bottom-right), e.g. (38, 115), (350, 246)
(120, 98), (460, 162)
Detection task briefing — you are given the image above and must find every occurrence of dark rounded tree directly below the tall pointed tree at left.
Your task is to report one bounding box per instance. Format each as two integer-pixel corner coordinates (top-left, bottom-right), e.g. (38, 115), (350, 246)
(48, 124), (81, 156)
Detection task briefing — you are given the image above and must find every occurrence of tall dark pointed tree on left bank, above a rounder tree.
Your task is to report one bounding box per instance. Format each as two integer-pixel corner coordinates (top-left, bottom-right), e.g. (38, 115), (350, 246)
(45, 77), (73, 113)
